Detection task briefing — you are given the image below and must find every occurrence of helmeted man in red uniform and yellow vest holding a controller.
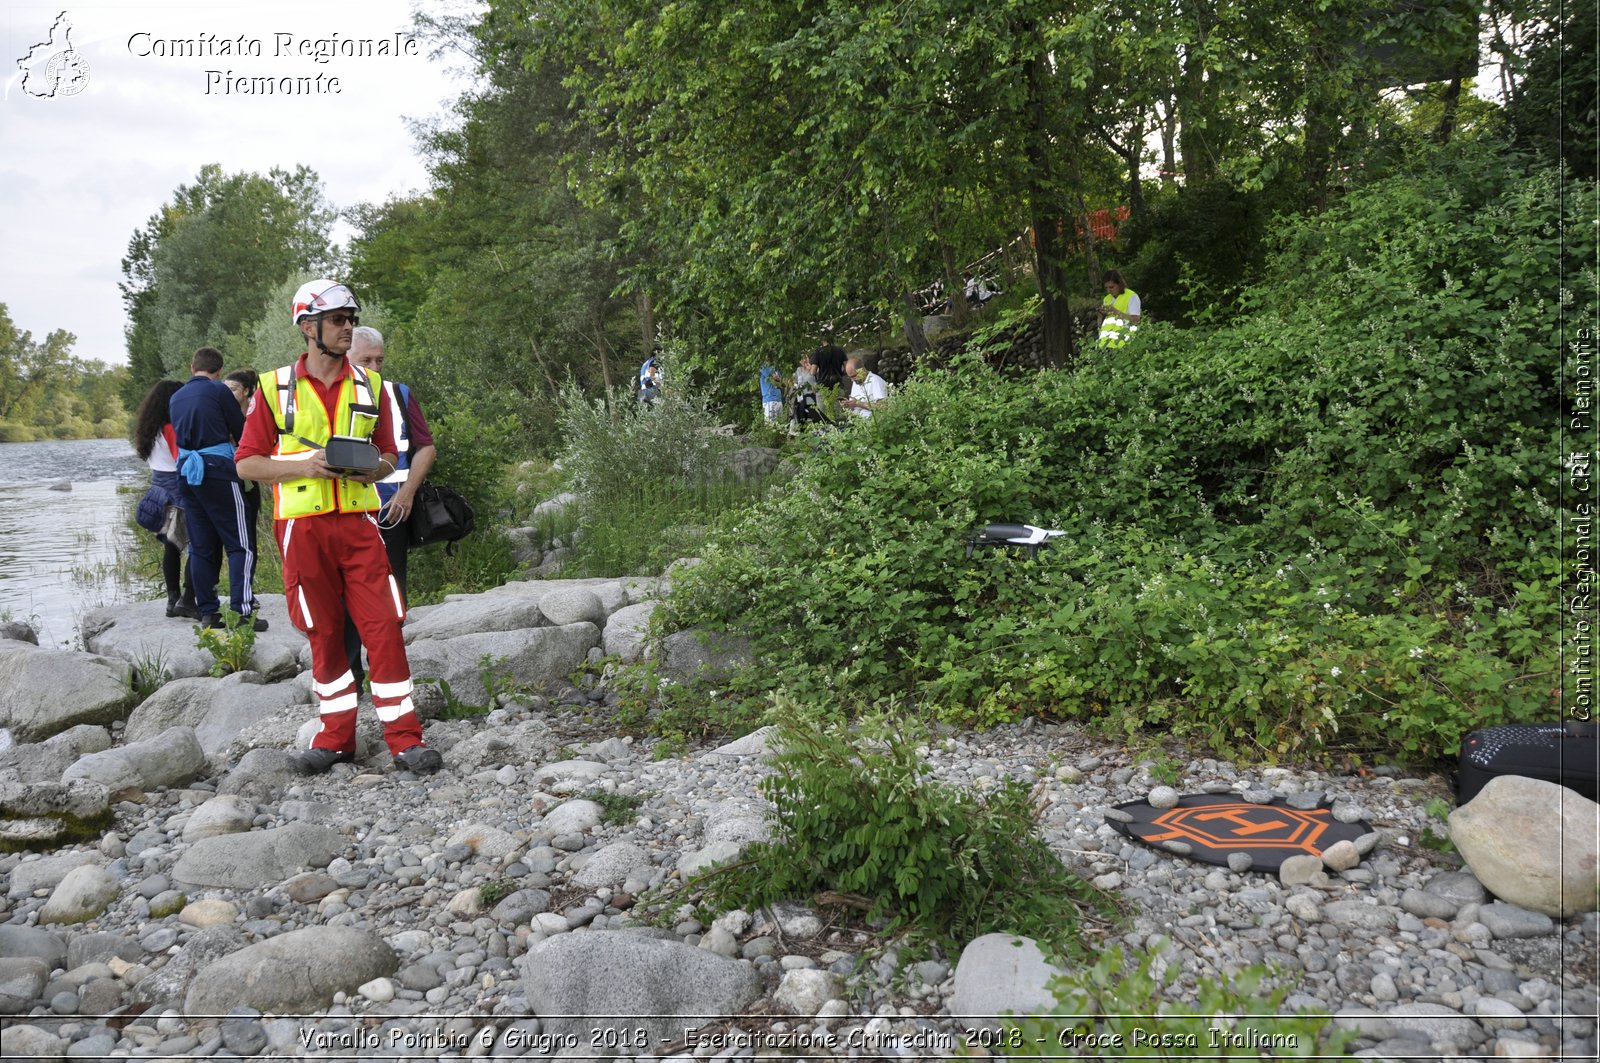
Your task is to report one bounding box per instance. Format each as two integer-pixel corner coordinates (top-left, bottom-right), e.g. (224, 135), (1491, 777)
(235, 279), (443, 775)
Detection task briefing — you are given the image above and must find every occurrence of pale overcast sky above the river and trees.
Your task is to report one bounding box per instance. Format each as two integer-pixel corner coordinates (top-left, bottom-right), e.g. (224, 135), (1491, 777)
(0, 0), (478, 363)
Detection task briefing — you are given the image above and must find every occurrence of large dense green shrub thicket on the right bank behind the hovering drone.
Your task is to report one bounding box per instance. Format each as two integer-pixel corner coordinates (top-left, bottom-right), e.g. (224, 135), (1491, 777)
(661, 144), (1595, 757)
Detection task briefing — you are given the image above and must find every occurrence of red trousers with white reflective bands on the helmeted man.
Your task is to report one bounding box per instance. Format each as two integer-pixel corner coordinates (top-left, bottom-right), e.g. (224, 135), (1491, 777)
(274, 512), (422, 752)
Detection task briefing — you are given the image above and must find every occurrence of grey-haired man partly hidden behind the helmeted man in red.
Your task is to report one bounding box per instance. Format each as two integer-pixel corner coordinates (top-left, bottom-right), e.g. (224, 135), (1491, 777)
(344, 325), (438, 687)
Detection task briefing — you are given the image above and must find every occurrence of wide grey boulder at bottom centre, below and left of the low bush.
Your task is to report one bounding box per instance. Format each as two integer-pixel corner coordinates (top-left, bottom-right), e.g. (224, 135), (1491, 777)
(522, 930), (762, 1047)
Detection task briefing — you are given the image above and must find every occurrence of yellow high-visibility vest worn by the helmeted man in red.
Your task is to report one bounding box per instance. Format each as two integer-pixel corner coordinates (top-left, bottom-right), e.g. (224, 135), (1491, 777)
(258, 365), (382, 520)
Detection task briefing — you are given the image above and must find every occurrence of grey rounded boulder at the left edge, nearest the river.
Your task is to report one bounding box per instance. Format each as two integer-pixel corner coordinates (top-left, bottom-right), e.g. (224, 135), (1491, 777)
(0, 633), (132, 741)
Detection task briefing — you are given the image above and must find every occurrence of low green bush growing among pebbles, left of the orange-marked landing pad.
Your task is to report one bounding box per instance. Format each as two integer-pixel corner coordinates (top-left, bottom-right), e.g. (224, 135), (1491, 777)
(701, 704), (1110, 956)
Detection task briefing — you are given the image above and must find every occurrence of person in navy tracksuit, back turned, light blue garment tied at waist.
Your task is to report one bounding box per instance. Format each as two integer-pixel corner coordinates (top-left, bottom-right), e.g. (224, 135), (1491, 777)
(166, 347), (267, 631)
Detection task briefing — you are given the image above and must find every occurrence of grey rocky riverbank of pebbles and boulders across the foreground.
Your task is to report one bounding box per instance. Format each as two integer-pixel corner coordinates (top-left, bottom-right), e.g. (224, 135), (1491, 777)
(0, 580), (1600, 1060)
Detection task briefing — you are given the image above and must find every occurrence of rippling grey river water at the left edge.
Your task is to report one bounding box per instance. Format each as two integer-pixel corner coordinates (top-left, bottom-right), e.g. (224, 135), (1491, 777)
(0, 439), (149, 648)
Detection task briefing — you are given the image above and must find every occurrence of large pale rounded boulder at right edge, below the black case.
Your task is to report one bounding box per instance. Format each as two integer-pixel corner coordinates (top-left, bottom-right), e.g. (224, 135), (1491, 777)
(1450, 775), (1600, 919)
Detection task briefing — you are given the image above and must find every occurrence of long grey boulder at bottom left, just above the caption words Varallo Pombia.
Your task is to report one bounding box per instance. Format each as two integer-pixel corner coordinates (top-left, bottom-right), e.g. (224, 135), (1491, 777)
(184, 927), (400, 1015)
